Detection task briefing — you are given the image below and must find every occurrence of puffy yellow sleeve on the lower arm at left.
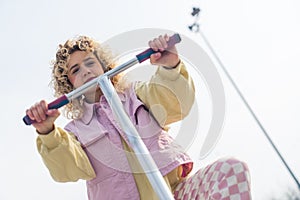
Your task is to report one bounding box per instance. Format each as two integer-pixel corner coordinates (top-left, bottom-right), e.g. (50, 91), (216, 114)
(37, 127), (96, 182)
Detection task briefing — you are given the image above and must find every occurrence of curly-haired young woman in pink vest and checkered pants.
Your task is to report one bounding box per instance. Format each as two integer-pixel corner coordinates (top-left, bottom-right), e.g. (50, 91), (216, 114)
(26, 35), (251, 200)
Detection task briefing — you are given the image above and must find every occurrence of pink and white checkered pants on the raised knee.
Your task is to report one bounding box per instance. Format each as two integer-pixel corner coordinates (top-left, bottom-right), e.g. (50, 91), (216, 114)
(174, 158), (251, 200)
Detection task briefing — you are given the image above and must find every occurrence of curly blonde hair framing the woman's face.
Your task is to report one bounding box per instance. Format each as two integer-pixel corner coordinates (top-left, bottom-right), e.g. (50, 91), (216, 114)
(51, 36), (121, 119)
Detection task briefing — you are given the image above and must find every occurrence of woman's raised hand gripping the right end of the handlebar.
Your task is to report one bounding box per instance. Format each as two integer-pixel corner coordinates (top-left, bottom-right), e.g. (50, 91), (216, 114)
(148, 34), (179, 68)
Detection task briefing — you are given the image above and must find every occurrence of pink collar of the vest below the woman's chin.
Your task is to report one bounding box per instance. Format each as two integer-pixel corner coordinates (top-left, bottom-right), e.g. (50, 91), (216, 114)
(80, 93), (125, 125)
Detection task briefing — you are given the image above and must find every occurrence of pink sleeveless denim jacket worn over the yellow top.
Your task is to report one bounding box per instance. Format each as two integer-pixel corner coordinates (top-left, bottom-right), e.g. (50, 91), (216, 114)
(65, 85), (192, 200)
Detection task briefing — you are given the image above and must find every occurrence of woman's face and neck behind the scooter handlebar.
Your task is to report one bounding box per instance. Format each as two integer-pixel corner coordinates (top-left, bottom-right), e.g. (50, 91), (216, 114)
(67, 51), (104, 101)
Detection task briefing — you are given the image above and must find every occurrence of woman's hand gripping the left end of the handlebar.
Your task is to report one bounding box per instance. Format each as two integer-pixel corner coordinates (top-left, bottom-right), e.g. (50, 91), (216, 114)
(26, 100), (60, 134)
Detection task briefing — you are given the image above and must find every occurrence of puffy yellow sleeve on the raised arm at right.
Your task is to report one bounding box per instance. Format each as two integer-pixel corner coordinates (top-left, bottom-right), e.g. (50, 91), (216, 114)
(135, 62), (195, 127)
